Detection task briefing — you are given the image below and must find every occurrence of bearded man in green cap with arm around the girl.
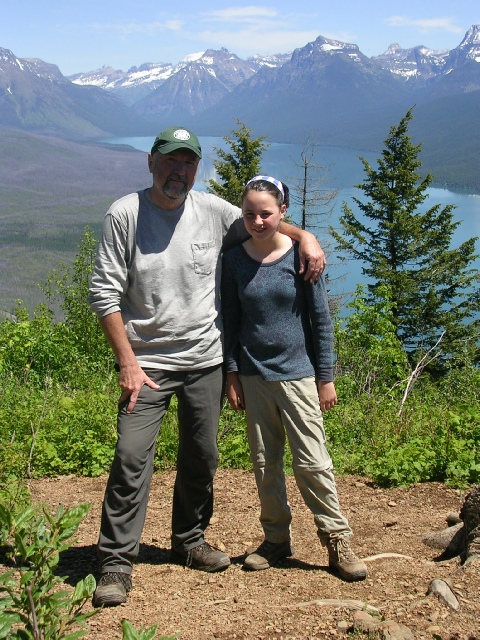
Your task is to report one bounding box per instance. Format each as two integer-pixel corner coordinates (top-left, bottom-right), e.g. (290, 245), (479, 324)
(88, 127), (325, 606)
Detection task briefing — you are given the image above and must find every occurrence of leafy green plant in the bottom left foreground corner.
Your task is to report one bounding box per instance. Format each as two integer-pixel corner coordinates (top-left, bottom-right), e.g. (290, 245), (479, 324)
(0, 504), (96, 640)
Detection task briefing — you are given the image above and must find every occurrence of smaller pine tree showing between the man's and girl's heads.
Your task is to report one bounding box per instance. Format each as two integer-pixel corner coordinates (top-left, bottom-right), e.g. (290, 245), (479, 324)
(207, 120), (268, 206)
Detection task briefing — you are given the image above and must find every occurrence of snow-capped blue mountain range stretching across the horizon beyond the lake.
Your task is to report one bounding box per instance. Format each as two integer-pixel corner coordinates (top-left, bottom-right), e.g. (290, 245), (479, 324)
(0, 25), (480, 191)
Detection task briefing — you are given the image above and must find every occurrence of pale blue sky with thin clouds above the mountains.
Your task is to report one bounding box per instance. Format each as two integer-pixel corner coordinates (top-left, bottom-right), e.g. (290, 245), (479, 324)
(0, 0), (480, 76)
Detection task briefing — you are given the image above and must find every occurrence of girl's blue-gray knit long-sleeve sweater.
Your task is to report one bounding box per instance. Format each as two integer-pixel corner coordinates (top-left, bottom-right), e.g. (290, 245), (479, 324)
(221, 243), (333, 381)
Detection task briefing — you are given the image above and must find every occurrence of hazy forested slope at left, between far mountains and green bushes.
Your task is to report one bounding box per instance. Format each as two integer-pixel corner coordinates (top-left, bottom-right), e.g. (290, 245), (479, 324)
(0, 127), (149, 311)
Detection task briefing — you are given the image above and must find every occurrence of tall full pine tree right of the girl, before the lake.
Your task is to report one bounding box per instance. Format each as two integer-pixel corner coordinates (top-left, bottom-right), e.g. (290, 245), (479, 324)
(331, 109), (480, 360)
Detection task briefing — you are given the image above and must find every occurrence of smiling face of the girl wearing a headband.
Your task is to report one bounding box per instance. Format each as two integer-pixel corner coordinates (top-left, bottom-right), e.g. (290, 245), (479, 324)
(242, 189), (286, 241)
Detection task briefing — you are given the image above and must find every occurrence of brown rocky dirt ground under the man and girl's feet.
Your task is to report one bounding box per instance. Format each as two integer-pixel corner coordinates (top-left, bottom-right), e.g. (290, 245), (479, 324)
(26, 471), (480, 640)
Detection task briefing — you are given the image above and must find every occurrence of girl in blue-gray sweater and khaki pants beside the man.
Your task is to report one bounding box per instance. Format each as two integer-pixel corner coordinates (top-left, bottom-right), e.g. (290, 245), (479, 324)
(222, 176), (367, 581)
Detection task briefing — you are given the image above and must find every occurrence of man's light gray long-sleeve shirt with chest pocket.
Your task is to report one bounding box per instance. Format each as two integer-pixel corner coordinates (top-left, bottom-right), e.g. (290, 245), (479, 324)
(88, 190), (245, 371)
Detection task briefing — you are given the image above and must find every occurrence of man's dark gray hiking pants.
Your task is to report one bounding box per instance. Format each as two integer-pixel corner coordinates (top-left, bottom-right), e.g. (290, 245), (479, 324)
(98, 365), (223, 573)
